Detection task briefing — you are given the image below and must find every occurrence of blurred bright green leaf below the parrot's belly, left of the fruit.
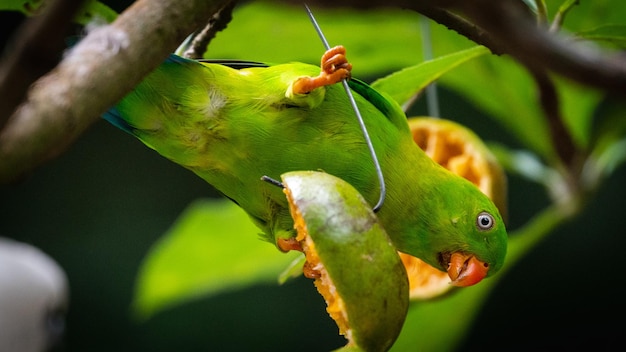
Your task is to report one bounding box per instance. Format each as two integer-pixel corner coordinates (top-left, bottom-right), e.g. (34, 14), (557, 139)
(132, 200), (298, 319)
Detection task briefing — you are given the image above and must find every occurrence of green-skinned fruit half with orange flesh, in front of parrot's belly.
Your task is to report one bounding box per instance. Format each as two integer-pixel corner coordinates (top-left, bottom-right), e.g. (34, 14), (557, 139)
(281, 171), (409, 351)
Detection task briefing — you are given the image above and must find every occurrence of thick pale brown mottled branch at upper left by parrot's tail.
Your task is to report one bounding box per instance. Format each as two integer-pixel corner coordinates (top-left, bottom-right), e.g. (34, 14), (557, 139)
(0, 0), (226, 183)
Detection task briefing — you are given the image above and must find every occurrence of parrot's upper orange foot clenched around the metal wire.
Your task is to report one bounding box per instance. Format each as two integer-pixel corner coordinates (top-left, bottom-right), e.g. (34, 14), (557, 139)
(293, 45), (352, 94)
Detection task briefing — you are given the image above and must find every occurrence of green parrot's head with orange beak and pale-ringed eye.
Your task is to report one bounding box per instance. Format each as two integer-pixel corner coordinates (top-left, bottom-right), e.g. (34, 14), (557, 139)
(386, 168), (508, 286)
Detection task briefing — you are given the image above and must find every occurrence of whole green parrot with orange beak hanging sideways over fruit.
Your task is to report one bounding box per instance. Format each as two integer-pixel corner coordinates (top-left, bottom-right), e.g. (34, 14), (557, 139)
(104, 46), (507, 286)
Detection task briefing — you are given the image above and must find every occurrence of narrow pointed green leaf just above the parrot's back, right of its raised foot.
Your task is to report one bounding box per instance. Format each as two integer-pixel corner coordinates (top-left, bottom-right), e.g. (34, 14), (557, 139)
(372, 46), (489, 110)
